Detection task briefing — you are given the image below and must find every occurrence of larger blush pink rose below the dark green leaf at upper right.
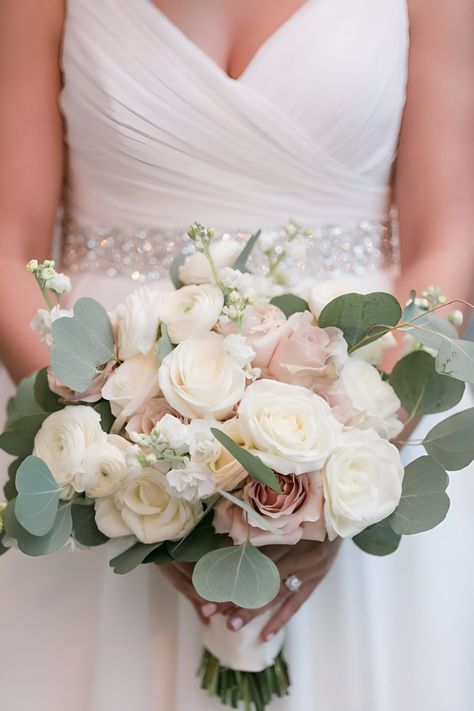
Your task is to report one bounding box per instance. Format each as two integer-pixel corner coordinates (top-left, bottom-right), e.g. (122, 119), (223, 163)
(267, 311), (348, 388)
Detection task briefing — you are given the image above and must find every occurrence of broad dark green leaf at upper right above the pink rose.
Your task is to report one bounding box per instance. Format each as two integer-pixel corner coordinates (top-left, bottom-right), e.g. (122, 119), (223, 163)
(318, 291), (402, 351)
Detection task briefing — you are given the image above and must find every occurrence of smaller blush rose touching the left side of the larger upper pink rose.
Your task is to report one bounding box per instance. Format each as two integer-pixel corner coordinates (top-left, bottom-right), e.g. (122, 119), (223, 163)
(216, 303), (286, 368)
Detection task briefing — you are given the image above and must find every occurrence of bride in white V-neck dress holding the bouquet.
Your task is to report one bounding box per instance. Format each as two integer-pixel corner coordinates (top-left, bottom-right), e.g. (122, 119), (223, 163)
(0, 0), (474, 711)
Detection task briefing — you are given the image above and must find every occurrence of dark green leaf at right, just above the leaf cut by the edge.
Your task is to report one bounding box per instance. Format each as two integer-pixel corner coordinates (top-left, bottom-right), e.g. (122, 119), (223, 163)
(390, 351), (464, 417)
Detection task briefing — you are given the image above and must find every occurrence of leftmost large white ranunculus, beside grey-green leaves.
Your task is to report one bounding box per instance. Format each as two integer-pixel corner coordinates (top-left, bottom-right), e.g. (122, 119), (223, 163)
(33, 405), (107, 488)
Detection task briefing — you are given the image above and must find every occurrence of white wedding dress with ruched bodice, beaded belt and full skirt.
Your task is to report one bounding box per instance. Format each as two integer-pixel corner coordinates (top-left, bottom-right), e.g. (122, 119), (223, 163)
(0, 0), (474, 711)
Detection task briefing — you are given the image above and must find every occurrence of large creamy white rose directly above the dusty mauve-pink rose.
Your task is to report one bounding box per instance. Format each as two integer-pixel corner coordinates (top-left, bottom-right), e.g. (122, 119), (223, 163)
(239, 380), (341, 474)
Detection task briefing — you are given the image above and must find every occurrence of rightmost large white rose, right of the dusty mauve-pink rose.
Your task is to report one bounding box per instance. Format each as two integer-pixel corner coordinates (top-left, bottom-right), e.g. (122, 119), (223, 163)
(323, 430), (403, 540)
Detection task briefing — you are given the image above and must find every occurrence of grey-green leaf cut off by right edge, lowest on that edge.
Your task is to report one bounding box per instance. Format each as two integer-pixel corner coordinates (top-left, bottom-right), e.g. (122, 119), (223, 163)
(423, 407), (474, 471)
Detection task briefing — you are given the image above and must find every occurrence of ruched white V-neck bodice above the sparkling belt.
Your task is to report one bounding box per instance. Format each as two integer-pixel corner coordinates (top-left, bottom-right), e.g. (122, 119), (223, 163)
(61, 0), (408, 229)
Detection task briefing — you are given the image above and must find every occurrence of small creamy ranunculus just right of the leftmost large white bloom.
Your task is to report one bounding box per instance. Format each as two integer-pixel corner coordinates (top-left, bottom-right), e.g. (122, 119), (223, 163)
(74, 435), (133, 499)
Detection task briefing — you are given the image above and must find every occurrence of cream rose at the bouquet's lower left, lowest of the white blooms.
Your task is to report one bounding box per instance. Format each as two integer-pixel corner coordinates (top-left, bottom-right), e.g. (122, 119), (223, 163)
(95, 467), (202, 543)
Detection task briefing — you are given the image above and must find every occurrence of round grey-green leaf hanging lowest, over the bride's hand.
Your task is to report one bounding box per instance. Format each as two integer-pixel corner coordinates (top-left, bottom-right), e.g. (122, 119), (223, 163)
(193, 541), (280, 610)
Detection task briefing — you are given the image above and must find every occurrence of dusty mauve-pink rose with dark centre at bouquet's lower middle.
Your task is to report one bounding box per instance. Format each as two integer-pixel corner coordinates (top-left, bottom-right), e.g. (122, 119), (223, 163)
(214, 472), (326, 546)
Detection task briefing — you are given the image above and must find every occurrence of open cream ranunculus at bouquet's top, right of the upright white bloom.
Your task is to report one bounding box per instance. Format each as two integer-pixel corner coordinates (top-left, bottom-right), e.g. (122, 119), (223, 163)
(161, 284), (224, 343)
